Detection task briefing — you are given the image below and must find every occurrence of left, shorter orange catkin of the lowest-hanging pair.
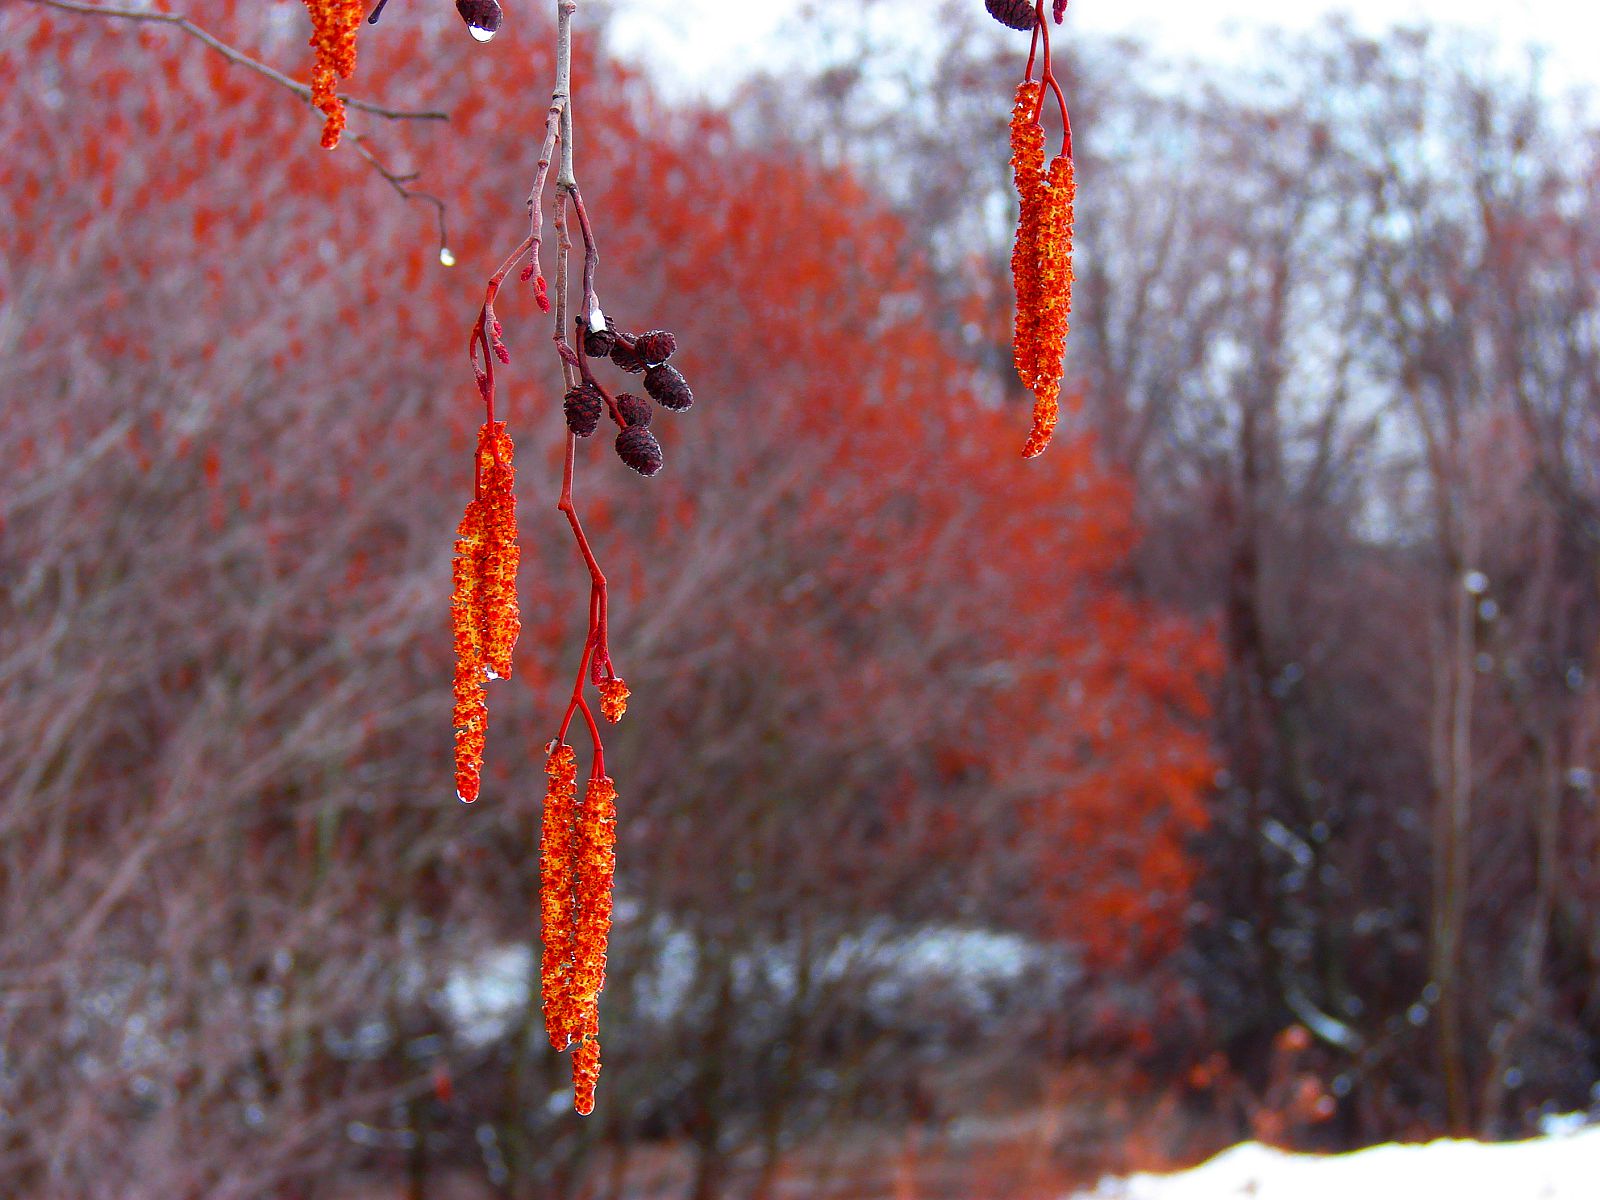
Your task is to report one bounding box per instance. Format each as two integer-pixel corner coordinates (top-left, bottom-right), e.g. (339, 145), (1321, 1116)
(539, 742), (582, 1050)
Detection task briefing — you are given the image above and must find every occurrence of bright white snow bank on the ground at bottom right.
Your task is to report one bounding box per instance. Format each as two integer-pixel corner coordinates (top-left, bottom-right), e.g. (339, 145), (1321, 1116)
(1077, 1125), (1600, 1200)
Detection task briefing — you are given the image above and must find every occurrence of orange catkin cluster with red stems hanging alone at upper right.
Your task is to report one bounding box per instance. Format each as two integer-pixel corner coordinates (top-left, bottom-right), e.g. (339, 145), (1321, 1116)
(987, 0), (1075, 458)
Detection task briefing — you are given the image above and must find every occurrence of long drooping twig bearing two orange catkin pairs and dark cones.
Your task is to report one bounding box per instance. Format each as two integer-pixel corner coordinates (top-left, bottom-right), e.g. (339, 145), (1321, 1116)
(451, 0), (707, 1114)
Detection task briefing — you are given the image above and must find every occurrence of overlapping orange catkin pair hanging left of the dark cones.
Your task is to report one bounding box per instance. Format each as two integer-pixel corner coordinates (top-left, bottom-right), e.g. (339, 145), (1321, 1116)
(450, 421), (522, 803)
